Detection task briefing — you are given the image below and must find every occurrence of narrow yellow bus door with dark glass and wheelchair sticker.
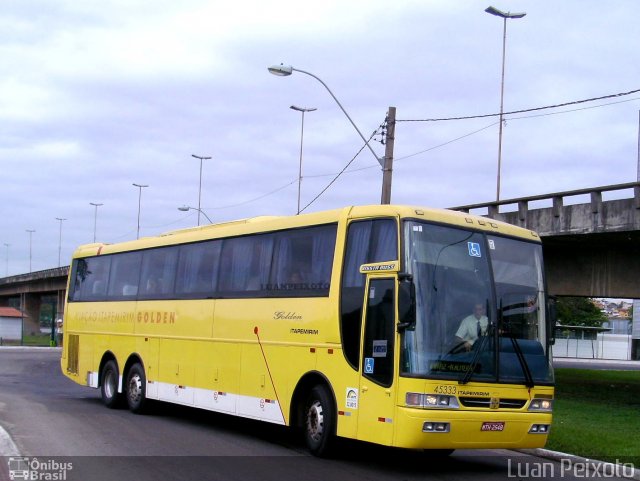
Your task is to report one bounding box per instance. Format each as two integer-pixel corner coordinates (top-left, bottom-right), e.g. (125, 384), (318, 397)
(358, 277), (397, 445)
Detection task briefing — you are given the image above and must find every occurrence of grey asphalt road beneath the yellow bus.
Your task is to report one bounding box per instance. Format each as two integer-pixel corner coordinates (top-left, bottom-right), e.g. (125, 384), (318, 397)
(0, 349), (632, 481)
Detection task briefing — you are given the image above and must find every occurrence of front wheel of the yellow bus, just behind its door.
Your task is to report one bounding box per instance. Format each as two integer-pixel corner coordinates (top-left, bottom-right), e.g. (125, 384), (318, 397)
(304, 384), (335, 457)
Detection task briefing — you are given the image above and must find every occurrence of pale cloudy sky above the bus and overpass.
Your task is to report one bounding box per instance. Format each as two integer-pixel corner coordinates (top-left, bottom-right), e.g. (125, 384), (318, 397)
(0, 0), (640, 277)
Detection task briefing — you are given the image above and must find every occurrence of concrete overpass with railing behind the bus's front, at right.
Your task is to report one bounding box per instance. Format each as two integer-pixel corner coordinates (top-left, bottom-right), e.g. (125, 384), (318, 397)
(453, 182), (640, 299)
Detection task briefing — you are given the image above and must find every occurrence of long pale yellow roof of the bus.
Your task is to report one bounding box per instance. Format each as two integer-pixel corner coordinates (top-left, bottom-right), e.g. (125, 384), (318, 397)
(73, 204), (540, 257)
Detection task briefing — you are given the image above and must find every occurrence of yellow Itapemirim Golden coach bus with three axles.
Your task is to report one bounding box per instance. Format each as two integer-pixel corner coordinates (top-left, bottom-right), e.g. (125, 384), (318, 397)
(61, 205), (554, 456)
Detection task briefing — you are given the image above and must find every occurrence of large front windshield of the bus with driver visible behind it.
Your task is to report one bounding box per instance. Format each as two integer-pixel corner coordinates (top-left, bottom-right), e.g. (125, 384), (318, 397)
(400, 221), (553, 386)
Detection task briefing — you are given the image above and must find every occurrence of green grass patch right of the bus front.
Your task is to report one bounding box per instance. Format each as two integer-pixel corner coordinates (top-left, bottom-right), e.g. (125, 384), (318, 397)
(546, 369), (640, 466)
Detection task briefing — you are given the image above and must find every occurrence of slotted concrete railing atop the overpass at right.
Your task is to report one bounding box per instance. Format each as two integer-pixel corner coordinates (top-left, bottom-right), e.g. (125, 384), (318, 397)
(450, 182), (640, 220)
